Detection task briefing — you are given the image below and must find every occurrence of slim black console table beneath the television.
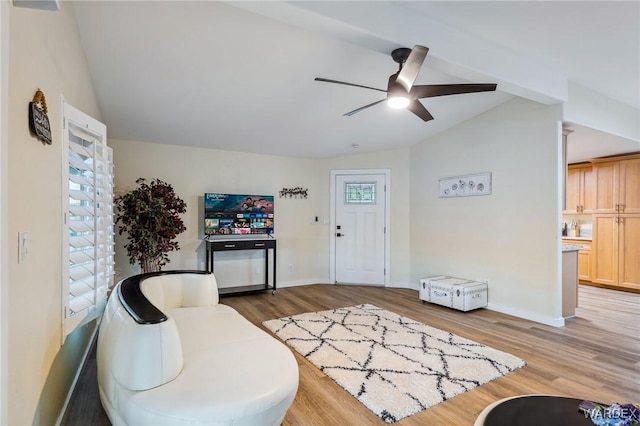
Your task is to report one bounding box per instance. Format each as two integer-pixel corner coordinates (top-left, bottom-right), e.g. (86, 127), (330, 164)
(206, 238), (277, 296)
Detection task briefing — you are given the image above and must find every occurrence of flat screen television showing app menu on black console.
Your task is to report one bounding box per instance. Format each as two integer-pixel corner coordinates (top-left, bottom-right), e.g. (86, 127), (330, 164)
(204, 192), (273, 236)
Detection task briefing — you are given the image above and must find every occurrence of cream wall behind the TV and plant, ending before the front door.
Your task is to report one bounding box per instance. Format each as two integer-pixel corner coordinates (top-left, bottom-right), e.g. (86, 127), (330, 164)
(109, 139), (328, 286)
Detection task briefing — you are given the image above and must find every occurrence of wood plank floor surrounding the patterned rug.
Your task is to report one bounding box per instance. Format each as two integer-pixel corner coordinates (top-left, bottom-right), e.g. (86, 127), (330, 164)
(62, 285), (640, 426)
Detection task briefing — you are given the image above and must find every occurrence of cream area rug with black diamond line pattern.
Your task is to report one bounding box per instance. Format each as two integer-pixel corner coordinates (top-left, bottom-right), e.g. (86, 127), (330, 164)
(263, 304), (526, 423)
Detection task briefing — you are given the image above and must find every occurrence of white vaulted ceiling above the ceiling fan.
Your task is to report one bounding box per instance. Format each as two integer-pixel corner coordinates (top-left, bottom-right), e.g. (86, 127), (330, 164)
(74, 1), (640, 158)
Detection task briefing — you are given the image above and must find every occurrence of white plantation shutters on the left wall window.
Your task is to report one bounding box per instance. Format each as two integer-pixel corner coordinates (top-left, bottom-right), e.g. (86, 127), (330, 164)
(63, 103), (114, 336)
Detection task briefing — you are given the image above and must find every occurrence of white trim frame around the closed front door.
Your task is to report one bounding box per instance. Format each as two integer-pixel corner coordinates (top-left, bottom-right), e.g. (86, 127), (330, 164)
(329, 169), (391, 287)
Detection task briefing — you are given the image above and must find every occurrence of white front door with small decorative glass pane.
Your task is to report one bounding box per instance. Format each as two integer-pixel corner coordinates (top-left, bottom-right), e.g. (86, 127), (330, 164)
(333, 174), (386, 285)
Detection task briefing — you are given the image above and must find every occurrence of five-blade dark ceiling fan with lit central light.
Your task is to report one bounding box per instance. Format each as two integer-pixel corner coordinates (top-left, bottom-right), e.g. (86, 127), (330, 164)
(315, 45), (496, 121)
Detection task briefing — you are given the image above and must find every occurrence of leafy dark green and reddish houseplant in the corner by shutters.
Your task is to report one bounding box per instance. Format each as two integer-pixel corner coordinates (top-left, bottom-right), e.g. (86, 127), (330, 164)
(114, 178), (187, 272)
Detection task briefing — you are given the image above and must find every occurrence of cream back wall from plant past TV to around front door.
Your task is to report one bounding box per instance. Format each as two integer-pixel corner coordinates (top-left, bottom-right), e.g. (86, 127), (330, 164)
(109, 139), (410, 287)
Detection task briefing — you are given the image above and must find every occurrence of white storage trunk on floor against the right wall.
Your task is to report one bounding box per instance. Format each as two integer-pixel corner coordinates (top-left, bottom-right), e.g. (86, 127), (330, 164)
(420, 276), (488, 312)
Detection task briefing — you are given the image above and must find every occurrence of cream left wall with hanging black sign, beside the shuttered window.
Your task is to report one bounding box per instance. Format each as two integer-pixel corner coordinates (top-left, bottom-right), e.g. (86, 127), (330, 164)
(7, 2), (100, 425)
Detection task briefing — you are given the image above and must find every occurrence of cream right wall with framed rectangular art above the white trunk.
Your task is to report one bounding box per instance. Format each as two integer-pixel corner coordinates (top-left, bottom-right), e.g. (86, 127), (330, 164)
(410, 99), (562, 324)
